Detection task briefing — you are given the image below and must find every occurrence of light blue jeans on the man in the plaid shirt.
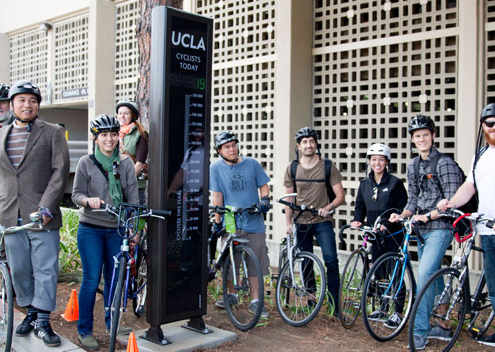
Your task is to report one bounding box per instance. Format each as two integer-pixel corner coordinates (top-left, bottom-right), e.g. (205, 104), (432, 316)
(414, 229), (453, 336)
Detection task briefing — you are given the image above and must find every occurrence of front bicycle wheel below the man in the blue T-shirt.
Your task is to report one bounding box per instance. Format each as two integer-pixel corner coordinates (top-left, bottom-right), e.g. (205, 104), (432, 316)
(222, 244), (264, 331)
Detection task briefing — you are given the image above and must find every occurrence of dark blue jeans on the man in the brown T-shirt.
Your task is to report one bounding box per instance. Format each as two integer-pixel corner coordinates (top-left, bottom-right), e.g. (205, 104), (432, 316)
(297, 221), (340, 309)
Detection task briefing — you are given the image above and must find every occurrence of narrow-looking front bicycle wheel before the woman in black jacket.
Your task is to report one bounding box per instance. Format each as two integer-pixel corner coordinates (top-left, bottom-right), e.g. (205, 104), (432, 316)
(339, 248), (366, 329)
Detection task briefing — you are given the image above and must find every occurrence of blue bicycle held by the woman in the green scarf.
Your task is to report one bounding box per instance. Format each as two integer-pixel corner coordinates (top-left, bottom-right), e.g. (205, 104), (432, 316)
(93, 203), (171, 352)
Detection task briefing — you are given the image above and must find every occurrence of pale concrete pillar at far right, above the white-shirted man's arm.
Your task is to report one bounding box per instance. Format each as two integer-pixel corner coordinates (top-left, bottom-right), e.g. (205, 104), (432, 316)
(456, 0), (483, 169)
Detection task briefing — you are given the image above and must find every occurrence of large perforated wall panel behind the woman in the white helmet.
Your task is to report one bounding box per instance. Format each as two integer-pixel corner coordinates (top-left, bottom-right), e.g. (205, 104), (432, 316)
(313, 0), (458, 262)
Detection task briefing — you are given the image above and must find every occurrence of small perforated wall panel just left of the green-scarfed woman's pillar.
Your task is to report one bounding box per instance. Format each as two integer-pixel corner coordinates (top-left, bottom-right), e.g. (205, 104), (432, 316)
(53, 14), (89, 102)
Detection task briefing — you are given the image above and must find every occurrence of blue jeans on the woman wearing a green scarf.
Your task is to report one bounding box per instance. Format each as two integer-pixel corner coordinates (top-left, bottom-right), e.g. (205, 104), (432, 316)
(77, 223), (122, 336)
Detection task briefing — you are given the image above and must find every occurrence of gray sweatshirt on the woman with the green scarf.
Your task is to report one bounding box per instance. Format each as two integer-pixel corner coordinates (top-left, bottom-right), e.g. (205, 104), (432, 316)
(72, 155), (139, 228)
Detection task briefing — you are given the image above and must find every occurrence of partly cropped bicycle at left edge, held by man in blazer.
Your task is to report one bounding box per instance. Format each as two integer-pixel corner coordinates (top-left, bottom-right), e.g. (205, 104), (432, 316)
(0, 211), (43, 351)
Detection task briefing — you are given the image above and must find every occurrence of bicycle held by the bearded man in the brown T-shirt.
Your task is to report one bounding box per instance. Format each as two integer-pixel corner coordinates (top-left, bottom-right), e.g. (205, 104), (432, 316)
(275, 193), (326, 327)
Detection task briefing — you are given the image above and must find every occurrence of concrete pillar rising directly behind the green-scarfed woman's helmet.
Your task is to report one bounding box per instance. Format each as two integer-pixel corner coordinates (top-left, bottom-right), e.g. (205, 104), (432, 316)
(88, 0), (115, 148)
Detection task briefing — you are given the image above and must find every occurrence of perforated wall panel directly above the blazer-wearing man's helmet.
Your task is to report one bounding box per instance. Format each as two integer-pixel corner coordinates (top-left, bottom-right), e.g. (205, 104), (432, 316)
(9, 29), (50, 104)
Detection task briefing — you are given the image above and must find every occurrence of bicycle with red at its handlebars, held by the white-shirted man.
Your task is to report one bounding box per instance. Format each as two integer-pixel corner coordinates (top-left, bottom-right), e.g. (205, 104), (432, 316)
(408, 209), (495, 351)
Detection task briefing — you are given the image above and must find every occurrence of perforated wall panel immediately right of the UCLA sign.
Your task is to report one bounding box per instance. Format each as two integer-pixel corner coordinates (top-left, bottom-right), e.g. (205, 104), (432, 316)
(193, 0), (276, 238)
